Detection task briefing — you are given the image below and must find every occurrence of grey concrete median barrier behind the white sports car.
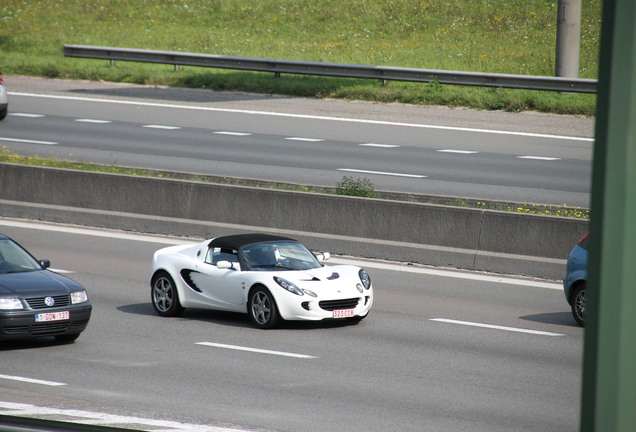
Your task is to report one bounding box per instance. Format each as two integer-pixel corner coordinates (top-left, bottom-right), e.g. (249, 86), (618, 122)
(0, 164), (588, 279)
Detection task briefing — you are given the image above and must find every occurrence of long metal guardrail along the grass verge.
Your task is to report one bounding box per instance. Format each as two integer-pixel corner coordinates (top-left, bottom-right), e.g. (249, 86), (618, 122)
(64, 45), (597, 93)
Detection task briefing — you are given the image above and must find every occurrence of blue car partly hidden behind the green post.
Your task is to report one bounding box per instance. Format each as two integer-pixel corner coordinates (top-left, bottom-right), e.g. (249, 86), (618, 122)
(563, 233), (590, 326)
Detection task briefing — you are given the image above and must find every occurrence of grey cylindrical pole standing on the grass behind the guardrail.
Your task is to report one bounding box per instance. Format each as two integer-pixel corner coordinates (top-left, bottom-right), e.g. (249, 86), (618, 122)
(555, 0), (582, 78)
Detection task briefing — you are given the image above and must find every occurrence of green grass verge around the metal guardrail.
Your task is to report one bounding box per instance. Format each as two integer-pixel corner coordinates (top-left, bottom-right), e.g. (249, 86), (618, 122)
(0, 0), (601, 115)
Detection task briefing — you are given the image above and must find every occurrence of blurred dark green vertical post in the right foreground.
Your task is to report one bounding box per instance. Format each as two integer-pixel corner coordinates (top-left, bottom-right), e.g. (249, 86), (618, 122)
(580, 0), (636, 432)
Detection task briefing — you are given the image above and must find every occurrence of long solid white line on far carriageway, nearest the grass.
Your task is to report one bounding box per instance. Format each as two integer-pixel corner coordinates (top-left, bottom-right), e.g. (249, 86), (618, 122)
(9, 92), (594, 142)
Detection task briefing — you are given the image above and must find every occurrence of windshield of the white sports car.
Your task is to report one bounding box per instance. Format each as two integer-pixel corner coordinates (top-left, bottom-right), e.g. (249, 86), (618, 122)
(242, 242), (322, 271)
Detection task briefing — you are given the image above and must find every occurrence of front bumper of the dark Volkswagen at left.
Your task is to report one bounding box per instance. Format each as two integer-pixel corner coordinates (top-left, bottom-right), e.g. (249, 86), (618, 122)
(0, 303), (93, 340)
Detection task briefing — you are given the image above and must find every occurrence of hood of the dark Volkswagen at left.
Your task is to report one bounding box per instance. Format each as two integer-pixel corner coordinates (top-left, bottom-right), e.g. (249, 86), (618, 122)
(0, 270), (84, 296)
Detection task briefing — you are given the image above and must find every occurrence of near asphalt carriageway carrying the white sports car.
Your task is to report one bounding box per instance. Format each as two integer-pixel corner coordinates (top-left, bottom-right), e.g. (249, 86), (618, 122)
(0, 219), (583, 432)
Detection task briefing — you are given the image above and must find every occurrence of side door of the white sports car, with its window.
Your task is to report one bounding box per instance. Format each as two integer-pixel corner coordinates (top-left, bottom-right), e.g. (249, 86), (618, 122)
(190, 248), (245, 310)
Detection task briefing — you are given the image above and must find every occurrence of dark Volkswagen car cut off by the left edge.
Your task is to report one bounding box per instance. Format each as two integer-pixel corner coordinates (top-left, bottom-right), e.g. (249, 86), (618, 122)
(0, 234), (92, 341)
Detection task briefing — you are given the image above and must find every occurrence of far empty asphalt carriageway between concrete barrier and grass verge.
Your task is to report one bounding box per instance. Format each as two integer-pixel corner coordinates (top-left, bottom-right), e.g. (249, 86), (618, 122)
(0, 77), (594, 207)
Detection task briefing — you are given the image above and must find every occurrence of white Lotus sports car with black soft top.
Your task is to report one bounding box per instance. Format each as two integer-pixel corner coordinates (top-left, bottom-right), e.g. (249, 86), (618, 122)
(150, 234), (373, 329)
